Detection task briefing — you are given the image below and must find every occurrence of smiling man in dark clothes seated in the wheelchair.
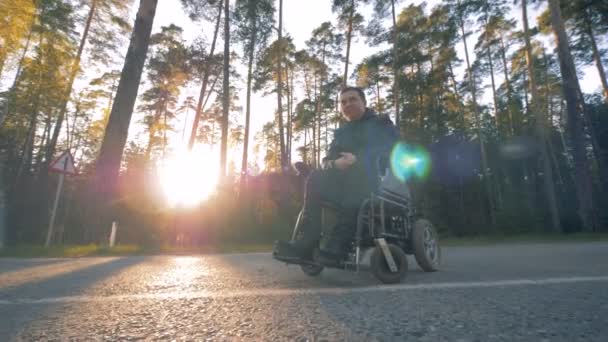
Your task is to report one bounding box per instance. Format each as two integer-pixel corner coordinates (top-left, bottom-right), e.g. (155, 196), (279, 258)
(273, 87), (399, 266)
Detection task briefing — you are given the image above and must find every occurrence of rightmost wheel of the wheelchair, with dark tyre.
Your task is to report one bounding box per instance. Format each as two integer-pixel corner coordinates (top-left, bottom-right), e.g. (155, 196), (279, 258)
(412, 219), (441, 272)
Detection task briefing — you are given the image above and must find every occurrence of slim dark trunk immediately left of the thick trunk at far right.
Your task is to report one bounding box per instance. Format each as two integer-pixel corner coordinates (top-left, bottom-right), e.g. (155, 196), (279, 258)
(521, 0), (562, 233)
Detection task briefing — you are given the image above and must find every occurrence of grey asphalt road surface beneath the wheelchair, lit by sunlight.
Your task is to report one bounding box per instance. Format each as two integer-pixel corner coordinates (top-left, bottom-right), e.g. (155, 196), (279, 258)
(0, 242), (608, 341)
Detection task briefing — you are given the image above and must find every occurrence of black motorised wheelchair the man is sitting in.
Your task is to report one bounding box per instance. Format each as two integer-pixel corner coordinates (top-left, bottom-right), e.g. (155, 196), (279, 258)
(278, 162), (441, 284)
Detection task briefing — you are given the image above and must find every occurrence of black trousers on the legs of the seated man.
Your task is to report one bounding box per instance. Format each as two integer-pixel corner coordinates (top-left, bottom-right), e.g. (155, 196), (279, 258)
(294, 169), (367, 254)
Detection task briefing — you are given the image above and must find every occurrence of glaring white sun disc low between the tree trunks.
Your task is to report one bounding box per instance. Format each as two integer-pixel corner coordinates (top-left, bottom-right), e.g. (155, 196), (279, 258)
(157, 146), (218, 207)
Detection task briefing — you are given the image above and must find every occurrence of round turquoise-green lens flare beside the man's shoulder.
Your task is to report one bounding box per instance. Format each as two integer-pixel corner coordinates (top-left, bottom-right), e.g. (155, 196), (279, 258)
(391, 142), (431, 182)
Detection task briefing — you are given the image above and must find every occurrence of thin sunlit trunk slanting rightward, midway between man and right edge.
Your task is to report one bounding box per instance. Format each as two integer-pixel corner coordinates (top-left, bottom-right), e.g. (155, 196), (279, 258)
(458, 6), (496, 230)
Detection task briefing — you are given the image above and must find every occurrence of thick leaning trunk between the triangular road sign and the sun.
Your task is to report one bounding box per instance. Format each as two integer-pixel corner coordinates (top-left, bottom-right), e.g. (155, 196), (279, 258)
(93, 0), (158, 235)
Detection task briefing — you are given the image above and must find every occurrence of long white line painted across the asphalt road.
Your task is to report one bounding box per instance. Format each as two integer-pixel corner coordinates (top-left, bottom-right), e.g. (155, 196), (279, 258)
(0, 276), (608, 305)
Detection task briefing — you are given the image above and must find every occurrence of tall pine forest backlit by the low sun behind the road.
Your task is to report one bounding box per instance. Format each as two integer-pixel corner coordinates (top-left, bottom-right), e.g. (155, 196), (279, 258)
(0, 0), (608, 247)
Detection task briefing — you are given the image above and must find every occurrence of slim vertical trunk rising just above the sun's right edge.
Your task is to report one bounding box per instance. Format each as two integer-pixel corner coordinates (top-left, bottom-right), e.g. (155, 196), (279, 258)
(220, 0), (230, 179)
